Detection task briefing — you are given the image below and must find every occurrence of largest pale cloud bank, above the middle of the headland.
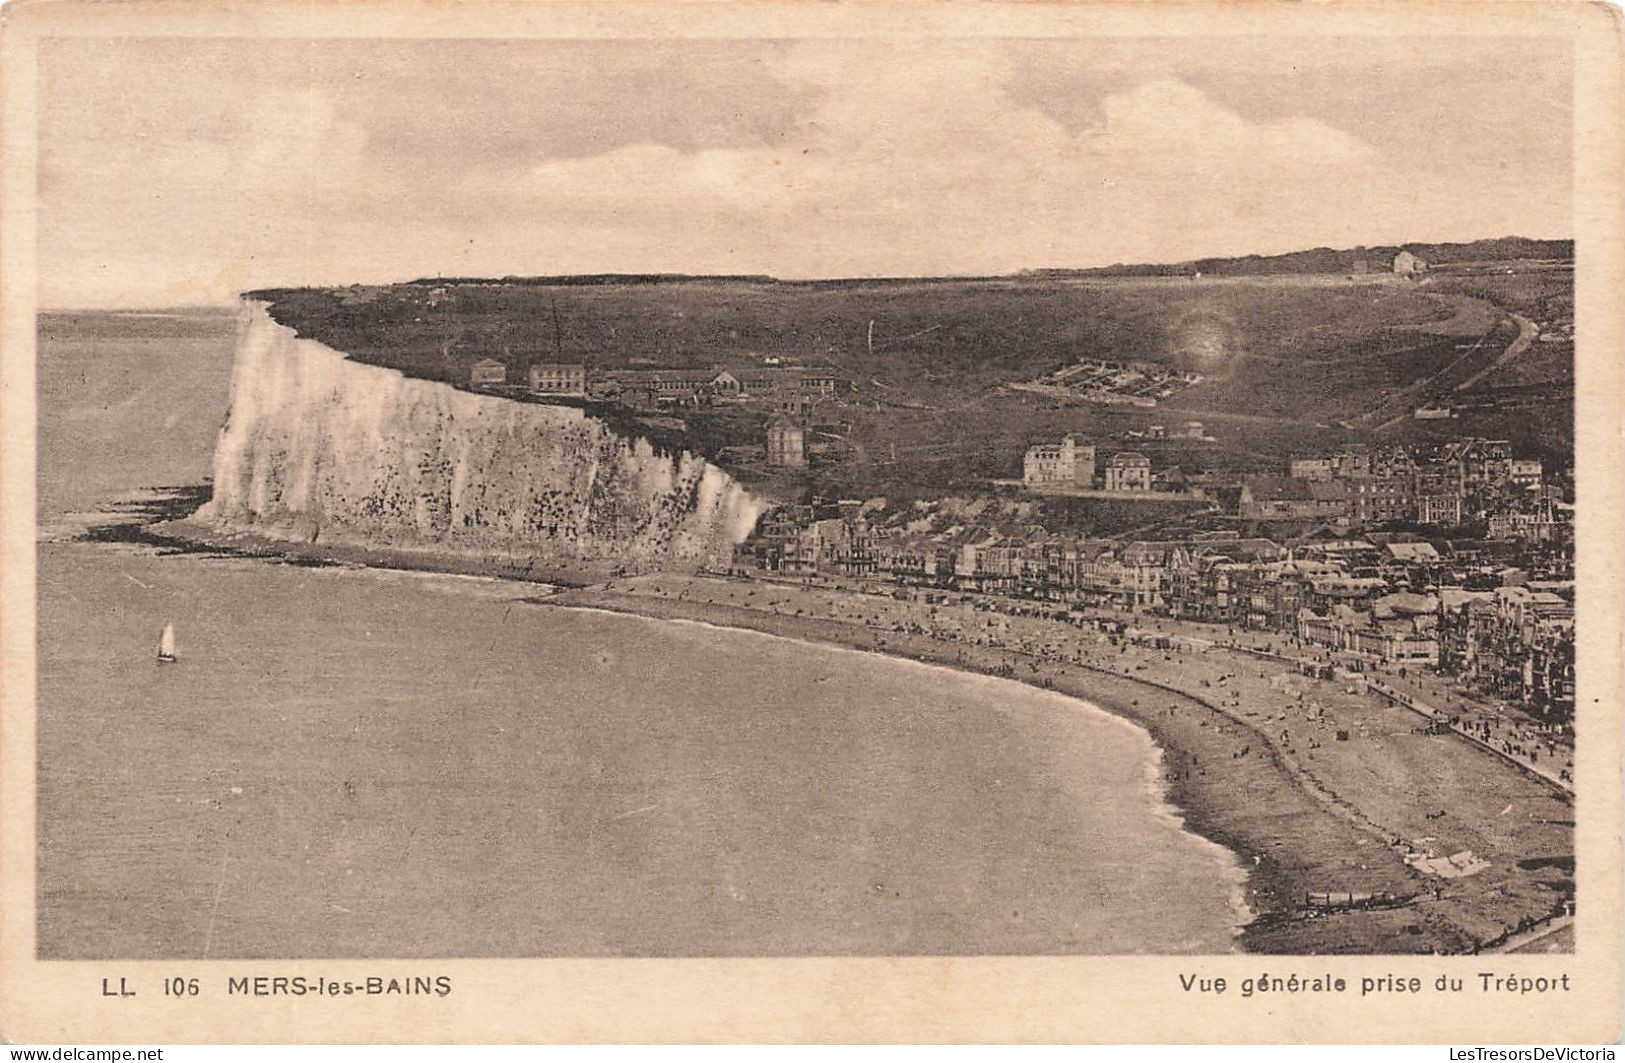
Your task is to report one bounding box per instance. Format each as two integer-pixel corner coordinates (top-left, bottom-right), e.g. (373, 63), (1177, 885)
(474, 44), (1373, 275)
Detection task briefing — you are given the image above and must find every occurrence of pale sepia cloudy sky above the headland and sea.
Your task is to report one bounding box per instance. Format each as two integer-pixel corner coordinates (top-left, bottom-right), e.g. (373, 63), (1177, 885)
(39, 37), (1573, 307)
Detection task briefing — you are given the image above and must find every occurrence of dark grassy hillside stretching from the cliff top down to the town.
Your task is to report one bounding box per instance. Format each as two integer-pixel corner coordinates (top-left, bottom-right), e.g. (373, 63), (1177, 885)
(257, 267), (1571, 499)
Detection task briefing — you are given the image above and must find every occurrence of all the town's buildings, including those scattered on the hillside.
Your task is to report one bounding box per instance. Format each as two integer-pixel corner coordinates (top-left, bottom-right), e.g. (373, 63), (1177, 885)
(431, 282), (1575, 757)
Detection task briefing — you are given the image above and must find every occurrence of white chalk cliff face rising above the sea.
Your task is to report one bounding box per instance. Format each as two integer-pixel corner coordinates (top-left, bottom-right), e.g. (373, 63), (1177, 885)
(197, 301), (765, 571)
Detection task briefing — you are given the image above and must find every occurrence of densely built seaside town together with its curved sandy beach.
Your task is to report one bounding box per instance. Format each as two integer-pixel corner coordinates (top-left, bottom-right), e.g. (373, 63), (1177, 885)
(536, 419), (1575, 952)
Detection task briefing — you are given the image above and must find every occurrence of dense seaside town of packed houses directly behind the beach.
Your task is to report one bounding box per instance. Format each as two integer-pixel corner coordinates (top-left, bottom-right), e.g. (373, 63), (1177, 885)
(724, 437), (1575, 731)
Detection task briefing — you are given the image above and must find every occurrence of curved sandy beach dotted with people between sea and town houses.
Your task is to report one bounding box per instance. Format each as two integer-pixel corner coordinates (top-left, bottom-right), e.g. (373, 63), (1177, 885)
(536, 575), (1573, 954)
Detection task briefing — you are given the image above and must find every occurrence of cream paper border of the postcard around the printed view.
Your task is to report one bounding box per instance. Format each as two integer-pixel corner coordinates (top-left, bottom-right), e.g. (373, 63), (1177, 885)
(0, 0), (1625, 1043)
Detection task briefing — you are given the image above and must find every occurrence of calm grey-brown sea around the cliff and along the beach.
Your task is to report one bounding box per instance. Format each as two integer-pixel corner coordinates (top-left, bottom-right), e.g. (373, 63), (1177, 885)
(37, 317), (1237, 957)
